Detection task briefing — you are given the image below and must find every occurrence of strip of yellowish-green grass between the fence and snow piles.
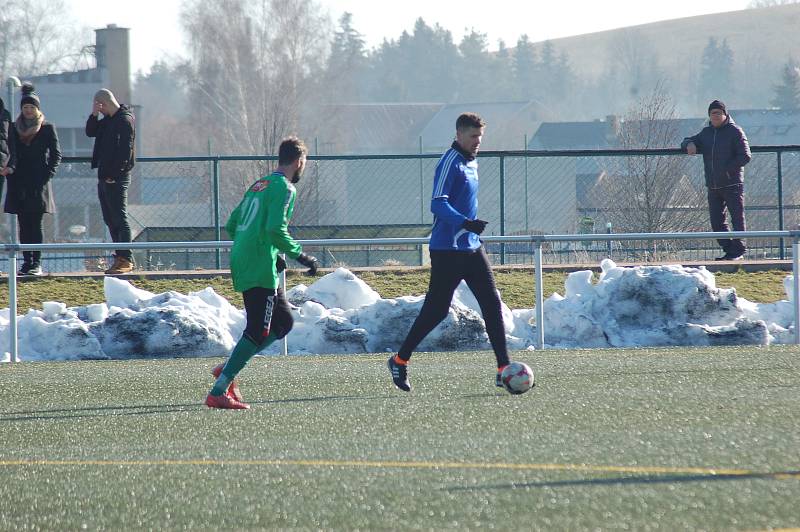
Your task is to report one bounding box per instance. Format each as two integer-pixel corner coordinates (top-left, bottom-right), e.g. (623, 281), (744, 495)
(0, 268), (787, 313)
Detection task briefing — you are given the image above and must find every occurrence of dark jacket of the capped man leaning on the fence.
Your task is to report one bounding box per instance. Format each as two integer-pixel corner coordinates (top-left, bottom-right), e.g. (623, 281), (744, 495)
(681, 115), (751, 188)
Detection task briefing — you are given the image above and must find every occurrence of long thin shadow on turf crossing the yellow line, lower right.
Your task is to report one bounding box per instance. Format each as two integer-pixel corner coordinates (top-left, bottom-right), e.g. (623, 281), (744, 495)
(442, 470), (800, 491)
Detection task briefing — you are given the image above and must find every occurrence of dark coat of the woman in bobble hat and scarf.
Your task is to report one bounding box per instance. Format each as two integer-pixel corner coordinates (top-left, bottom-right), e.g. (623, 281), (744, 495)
(5, 122), (61, 214)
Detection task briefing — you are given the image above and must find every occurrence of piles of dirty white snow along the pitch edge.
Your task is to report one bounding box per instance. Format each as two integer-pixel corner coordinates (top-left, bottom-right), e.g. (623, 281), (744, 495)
(0, 259), (794, 364)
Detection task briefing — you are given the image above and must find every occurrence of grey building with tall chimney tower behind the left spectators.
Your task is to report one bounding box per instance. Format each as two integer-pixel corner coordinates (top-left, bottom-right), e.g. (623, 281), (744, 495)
(6, 24), (213, 264)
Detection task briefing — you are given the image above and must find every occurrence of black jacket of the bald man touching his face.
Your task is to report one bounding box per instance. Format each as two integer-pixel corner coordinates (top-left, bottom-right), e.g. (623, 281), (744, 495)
(86, 105), (136, 179)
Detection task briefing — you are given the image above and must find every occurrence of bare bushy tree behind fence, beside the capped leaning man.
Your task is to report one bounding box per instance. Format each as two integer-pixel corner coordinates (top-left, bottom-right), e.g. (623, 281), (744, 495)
(592, 83), (707, 256)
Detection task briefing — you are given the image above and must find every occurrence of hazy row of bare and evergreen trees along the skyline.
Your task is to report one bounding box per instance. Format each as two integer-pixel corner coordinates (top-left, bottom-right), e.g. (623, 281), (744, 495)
(0, 0), (800, 153)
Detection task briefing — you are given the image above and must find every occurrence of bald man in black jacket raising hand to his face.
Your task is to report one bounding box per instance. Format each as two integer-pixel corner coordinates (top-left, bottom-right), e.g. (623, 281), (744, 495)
(86, 89), (136, 274)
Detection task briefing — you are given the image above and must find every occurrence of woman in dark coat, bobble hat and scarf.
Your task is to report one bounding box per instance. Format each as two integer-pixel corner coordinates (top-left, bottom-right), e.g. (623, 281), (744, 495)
(5, 84), (61, 275)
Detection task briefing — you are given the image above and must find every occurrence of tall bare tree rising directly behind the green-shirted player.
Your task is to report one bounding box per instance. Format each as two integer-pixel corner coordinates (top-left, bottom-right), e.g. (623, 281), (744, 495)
(183, 0), (332, 217)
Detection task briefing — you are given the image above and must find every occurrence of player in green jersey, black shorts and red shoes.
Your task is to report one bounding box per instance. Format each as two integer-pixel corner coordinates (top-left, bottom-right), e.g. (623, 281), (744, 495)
(206, 137), (319, 409)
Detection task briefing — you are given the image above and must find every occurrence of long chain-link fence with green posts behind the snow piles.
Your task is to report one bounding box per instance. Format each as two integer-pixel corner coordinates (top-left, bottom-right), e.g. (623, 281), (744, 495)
(0, 146), (800, 272)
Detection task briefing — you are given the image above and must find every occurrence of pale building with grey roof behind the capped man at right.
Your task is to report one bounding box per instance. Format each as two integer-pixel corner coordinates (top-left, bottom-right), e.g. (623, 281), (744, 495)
(528, 109), (800, 233)
